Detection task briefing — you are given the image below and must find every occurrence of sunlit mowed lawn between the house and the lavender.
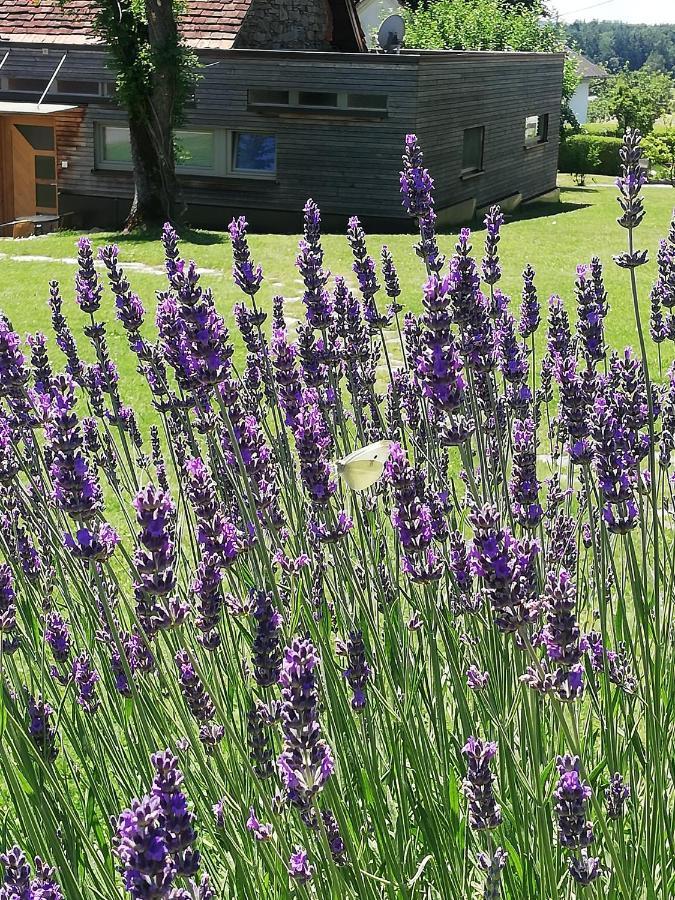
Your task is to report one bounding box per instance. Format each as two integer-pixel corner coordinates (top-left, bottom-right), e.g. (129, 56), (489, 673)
(0, 176), (675, 425)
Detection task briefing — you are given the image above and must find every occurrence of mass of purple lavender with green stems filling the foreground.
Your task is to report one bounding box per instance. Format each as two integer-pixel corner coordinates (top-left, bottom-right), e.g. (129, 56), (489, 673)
(0, 132), (675, 900)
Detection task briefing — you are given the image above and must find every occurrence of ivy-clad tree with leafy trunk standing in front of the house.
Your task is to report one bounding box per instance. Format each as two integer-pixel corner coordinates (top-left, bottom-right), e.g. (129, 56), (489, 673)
(73, 0), (197, 230)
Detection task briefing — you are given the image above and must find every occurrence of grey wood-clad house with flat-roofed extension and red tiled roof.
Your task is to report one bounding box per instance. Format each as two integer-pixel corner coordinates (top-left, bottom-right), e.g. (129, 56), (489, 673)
(0, 0), (563, 231)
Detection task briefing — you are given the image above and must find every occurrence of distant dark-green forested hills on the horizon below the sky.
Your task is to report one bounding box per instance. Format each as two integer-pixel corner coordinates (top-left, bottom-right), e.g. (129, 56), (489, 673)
(567, 21), (675, 76)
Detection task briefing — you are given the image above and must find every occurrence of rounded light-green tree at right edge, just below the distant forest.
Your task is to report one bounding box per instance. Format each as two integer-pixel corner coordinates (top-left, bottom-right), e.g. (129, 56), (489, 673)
(593, 68), (673, 134)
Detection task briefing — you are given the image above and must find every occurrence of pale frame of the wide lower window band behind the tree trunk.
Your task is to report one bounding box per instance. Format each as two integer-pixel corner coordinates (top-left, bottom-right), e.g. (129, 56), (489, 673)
(94, 122), (278, 181)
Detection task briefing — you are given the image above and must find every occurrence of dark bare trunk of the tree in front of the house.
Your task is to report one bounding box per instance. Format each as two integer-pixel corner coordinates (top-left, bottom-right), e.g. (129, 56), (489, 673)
(125, 0), (181, 231)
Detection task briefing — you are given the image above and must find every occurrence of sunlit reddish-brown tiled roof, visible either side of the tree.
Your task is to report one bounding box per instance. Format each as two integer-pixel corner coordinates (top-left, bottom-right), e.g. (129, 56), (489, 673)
(0, 0), (252, 47)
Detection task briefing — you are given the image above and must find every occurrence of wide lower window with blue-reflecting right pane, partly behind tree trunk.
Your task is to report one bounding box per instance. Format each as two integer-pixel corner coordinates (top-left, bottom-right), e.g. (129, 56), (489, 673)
(96, 123), (277, 178)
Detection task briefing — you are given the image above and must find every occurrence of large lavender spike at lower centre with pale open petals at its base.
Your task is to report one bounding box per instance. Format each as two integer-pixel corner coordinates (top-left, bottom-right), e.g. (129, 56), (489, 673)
(277, 638), (335, 809)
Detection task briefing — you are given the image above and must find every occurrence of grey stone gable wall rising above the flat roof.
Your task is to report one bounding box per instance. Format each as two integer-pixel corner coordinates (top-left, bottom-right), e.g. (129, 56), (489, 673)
(235, 0), (333, 50)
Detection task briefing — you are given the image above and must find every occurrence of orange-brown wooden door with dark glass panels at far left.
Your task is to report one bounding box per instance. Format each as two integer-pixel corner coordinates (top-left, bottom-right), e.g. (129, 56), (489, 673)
(8, 116), (58, 218)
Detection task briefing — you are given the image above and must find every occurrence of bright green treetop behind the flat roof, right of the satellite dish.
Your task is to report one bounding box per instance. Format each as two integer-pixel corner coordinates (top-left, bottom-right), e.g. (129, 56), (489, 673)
(404, 0), (574, 52)
